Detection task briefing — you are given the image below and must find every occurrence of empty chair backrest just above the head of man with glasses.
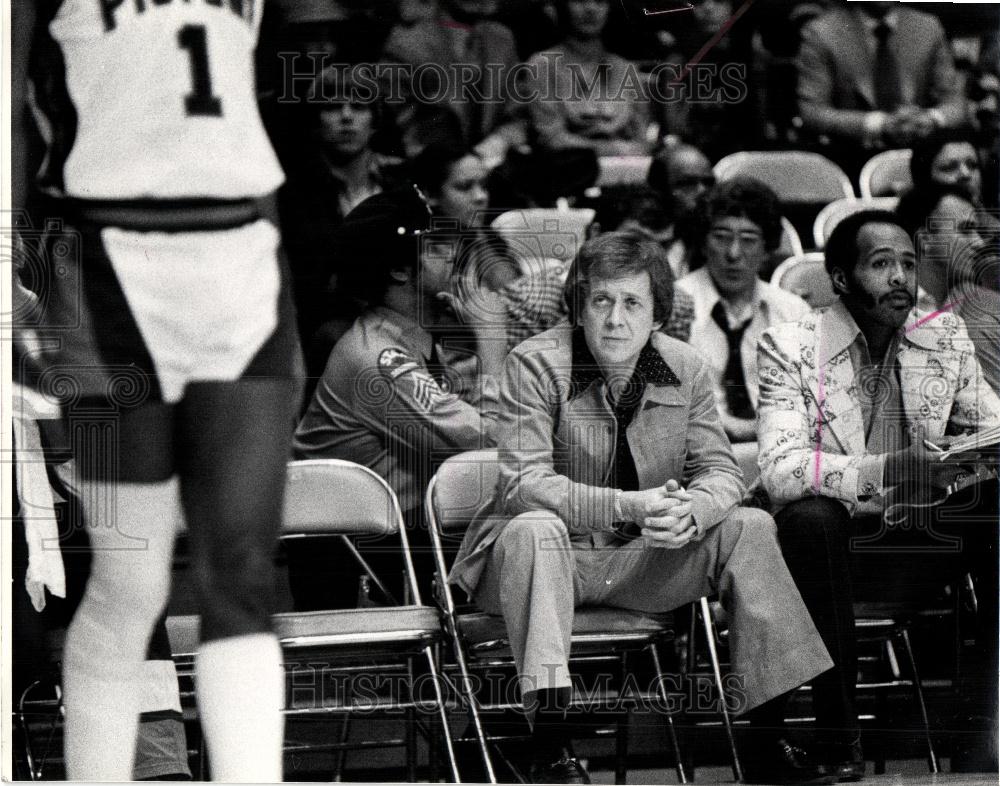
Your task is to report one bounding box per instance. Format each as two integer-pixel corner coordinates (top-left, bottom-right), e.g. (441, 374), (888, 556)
(712, 150), (854, 205)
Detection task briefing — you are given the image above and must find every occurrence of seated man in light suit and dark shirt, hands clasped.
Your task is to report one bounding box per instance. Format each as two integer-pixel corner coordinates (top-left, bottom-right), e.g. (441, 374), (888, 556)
(450, 233), (832, 783)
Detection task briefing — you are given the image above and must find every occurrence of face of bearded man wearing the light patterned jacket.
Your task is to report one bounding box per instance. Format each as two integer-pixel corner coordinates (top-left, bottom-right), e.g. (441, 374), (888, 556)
(847, 223), (917, 330)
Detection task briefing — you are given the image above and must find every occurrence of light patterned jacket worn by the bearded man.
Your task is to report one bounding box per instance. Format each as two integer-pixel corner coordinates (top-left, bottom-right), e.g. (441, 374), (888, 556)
(757, 302), (1000, 515)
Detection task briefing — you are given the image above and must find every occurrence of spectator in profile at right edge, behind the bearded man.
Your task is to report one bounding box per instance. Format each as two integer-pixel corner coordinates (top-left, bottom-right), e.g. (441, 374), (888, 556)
(896, 182), (1000, 392)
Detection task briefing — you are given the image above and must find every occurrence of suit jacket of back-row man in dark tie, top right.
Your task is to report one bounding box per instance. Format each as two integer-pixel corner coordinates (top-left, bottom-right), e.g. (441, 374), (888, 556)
(798, 6), (965, 141)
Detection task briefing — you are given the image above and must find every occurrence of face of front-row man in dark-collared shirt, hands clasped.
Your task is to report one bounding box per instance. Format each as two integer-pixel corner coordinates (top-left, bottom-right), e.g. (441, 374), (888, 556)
(580, 271), (660, 372)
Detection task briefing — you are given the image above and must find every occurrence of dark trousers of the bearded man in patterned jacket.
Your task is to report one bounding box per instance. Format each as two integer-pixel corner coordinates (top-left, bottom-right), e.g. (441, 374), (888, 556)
(775, 481), (998, 741)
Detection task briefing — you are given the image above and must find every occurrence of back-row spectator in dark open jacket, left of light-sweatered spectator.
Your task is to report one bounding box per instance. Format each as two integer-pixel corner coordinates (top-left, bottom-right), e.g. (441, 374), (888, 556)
(382, 0), (525, 165)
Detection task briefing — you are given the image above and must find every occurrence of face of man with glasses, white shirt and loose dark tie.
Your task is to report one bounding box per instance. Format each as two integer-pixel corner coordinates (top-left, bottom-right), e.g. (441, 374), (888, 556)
(704, 216), (768, 299)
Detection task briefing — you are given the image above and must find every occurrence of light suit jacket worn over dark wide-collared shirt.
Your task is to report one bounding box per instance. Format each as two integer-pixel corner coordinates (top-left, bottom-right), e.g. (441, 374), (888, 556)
(450, 324), (744, 594)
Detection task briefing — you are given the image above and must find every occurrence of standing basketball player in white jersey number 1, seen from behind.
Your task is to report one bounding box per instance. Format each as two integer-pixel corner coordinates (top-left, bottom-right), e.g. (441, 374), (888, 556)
(14, 0), (301, 782)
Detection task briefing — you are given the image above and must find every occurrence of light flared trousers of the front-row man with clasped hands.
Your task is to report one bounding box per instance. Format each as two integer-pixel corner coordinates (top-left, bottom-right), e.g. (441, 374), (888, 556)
(475, 508), (832, 712)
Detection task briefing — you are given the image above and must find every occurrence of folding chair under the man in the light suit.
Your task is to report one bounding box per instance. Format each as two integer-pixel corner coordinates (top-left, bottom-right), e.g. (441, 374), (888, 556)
(425, 450), (688, 783)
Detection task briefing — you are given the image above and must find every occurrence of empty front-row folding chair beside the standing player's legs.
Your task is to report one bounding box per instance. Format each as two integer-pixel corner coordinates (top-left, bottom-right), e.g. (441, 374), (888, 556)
(167, 459), (458, 782)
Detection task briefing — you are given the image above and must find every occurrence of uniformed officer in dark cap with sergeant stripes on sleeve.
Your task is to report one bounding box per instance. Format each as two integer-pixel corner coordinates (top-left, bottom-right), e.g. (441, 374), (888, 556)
(289, 186), (506, 610)
